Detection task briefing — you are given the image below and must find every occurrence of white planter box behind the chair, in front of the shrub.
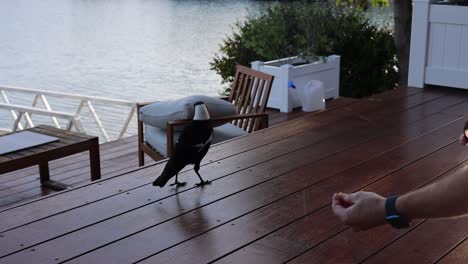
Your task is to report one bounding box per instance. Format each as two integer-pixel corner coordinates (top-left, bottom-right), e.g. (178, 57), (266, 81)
(252, 55), (340, 112)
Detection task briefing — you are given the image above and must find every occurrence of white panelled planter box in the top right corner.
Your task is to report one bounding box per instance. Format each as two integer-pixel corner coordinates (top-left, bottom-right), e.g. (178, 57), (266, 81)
(408, 0), (468, 89)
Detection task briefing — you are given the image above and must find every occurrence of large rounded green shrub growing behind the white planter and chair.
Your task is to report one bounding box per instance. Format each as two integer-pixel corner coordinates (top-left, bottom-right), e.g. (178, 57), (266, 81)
(211, 2), (398, 97)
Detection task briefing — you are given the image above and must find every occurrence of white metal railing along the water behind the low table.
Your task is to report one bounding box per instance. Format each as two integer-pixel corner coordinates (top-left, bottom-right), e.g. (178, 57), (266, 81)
(0, 86), (136, 142)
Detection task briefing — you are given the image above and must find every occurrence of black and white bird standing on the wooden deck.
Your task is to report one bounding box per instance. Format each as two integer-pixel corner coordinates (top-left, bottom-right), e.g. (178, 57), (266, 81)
(153, 102), (213, 187)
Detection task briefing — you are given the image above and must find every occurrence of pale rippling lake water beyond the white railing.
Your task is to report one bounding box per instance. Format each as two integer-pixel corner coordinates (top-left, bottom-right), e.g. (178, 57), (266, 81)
(0, 0), (392, 139)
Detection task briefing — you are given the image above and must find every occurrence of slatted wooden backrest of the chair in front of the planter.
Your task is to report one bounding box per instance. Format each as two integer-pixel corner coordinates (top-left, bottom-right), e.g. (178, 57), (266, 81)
(229, 65), (273, 132)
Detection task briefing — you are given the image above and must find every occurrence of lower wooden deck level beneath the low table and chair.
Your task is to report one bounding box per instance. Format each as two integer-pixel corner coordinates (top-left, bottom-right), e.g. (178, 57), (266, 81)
(0, 102), (330, 209)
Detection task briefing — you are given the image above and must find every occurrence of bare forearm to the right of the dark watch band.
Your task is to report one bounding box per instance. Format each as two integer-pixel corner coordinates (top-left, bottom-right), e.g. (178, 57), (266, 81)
(396, 168), (468, 219)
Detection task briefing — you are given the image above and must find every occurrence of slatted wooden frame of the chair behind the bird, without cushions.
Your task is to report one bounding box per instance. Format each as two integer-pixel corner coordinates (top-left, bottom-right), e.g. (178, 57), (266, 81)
(137, 65), (273, 166)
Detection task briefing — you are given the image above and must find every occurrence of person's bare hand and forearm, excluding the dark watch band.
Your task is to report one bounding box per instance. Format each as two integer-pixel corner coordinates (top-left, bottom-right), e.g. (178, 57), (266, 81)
(332, 133), (468, 230)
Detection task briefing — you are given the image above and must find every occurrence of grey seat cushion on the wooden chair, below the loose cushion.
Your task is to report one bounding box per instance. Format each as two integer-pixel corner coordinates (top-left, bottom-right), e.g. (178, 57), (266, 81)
(145, 123), (247, 157)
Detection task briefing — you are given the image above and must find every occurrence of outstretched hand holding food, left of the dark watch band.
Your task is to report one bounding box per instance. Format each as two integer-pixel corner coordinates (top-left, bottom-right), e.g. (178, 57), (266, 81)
(332, 192), (386, 231)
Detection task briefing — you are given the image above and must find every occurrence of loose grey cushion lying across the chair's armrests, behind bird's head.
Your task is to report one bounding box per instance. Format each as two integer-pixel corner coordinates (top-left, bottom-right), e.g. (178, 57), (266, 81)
(140, 95), (237, 130)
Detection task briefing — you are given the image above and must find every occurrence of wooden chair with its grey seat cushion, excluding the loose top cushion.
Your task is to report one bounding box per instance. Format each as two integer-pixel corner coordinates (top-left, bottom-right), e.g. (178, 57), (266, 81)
(137, 65), (273, 166)
